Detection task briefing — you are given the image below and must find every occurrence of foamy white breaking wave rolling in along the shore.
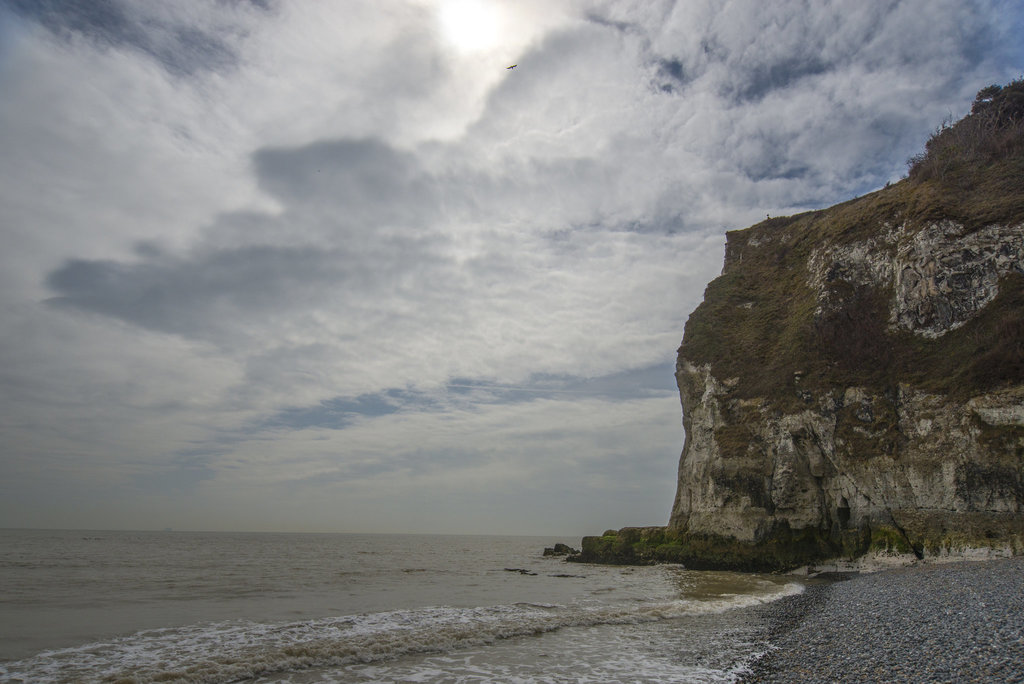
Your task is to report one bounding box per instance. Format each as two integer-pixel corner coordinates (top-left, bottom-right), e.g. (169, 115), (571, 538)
(0, 584), (803, 684)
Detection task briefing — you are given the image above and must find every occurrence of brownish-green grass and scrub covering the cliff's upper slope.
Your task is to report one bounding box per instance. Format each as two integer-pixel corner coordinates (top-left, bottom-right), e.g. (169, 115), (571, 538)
(679, 81), (1024, 411)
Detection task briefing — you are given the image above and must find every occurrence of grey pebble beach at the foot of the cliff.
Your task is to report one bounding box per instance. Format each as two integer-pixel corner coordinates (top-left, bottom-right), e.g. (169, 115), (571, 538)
(739, 557), (1024, 684)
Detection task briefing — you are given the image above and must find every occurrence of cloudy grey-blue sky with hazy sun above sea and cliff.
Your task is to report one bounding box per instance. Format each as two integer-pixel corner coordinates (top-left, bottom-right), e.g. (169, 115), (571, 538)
(0, 0), (1024, 541)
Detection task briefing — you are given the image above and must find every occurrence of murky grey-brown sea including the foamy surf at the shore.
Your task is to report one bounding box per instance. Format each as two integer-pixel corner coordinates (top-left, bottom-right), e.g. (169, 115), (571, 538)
(0, 529), (803, 684)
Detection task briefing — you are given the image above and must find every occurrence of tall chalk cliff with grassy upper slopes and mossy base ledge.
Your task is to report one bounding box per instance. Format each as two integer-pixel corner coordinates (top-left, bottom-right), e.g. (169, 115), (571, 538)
(582, 82), (1024, 569)
